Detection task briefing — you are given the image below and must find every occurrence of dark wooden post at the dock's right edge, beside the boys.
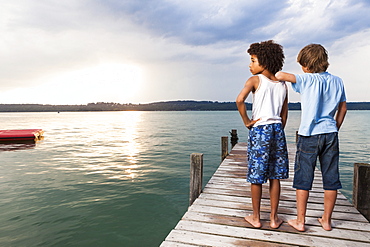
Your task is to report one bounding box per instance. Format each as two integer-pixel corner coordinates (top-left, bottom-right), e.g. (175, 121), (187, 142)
(352, 163), (370, 222)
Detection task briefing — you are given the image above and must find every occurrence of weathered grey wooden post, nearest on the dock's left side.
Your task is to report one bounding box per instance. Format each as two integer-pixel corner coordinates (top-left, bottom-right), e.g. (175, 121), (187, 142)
(189, 153), (203, 206)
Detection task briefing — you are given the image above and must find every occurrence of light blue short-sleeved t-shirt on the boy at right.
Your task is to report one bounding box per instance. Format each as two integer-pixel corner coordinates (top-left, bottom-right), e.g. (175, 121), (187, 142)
(292, 72), (346, 136)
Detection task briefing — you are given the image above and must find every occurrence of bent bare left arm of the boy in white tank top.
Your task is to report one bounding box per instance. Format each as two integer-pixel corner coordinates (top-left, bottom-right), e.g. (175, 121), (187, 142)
(236, 76), (259, 129)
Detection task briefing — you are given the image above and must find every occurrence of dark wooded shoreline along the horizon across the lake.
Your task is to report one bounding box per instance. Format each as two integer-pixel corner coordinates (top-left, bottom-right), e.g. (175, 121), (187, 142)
(0, 100), (370, 112)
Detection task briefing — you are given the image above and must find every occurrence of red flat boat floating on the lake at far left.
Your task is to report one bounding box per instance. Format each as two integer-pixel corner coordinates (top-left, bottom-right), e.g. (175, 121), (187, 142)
(0, 129), (44, 142)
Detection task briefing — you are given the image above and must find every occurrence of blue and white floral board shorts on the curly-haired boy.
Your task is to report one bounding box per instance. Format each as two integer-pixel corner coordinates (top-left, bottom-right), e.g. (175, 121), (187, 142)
(247, 123), (289, 184)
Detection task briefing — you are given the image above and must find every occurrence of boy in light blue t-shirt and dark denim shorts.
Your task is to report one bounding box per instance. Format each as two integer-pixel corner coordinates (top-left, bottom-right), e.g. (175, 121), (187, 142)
(276, 44), (347, 231)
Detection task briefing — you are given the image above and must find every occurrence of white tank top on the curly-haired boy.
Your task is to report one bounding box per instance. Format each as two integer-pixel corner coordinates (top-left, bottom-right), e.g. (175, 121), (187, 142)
(252, 74), (287, 126)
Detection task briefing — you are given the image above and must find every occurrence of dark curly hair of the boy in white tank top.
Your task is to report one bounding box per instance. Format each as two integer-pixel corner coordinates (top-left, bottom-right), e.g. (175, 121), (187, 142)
(247, 40), (285, 74)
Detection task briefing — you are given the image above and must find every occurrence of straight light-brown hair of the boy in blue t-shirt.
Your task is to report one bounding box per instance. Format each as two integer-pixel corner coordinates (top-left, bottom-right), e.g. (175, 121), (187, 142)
(297, 44), (329, 73)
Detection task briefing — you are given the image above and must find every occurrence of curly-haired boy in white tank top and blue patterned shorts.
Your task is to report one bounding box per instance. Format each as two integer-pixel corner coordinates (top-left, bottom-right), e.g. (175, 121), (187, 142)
(236, 40), (289, 228)
